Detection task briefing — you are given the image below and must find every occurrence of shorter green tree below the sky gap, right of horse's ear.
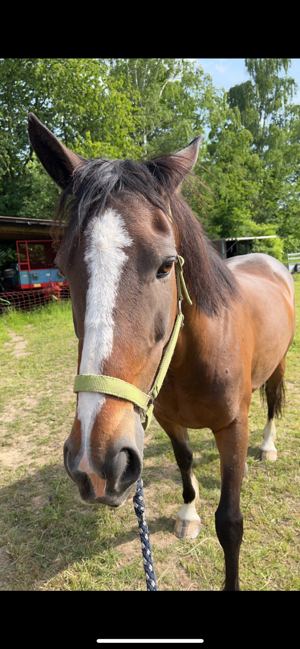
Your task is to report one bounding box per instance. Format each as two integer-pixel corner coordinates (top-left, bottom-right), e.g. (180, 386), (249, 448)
(199, 105), (262, 238)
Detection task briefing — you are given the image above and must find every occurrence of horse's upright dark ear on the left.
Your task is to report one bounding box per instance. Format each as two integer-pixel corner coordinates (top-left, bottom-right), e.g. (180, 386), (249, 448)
(28, 113), (87, 189)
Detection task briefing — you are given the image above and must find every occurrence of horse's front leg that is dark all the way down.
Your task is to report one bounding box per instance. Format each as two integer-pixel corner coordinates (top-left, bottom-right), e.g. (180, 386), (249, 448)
(214, 413), (248, 590)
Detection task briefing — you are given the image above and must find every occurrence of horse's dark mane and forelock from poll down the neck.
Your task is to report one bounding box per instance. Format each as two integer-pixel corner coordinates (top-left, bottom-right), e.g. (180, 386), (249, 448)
(57, 155), (239, 317)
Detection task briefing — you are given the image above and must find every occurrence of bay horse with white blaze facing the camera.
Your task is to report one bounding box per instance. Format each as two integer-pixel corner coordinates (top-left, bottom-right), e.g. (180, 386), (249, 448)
(28, 113), (295, 590)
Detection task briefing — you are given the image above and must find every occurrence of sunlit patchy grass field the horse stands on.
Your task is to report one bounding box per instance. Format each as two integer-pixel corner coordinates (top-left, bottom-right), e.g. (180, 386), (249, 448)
(0, 276), (300, 591)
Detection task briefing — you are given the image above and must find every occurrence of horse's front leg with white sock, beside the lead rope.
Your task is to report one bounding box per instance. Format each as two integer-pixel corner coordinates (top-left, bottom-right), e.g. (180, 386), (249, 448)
(156, 416), (200, 539)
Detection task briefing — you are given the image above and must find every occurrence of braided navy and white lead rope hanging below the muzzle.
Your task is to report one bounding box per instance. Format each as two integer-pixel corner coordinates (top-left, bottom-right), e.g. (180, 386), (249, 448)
(133, 478), (157, 590)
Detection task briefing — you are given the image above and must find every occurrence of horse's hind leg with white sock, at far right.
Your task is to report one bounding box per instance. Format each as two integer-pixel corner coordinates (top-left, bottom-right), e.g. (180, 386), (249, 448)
(259, 358), (285, 462)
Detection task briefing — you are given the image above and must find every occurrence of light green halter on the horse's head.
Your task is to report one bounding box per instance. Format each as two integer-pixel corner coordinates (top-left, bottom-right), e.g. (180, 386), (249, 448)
(74, 255), (192, 430)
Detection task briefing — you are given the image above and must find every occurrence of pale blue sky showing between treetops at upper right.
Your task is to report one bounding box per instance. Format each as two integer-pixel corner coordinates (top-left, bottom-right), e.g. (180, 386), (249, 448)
(196, 59), (300, 104)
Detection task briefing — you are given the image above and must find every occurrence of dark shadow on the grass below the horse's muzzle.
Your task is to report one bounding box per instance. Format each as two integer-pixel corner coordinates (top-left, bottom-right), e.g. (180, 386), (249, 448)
(0, 466), (134, 590)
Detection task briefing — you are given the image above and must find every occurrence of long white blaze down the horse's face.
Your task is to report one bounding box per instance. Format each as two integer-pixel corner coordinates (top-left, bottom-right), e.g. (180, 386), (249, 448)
(77, 209), (132, 476)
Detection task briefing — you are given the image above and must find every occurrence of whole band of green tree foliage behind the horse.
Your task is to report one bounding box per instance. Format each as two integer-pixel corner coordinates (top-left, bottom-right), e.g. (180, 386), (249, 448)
(0, 58), (300, 253)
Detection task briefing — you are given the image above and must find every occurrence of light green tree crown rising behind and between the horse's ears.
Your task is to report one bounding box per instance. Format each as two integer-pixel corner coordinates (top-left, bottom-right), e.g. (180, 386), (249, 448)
(109, 58), (217, 157)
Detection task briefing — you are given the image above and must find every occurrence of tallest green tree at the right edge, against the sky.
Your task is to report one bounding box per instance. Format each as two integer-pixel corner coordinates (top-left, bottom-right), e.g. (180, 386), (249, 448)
(216, 59), (300, 249)
